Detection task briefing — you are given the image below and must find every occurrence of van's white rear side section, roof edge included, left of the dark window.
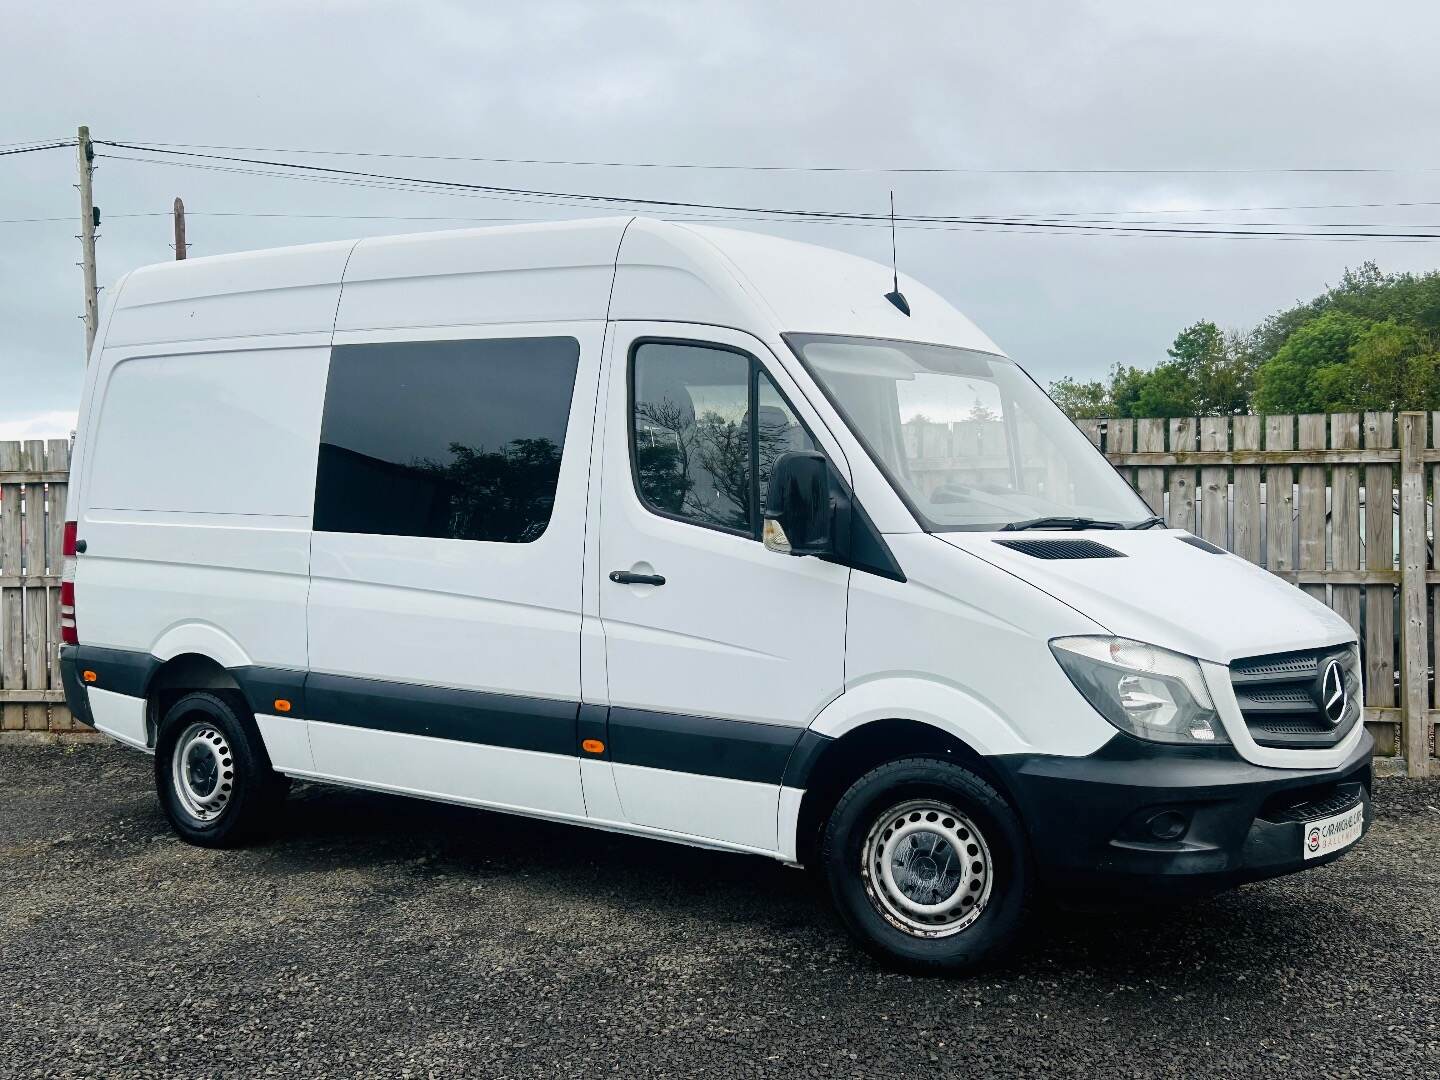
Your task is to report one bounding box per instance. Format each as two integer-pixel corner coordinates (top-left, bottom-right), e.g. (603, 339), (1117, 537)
(66, 240), (354, 760)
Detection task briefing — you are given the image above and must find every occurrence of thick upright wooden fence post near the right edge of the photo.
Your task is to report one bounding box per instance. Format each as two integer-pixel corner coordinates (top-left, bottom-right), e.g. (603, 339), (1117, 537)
(1393, 412), (1430, 776)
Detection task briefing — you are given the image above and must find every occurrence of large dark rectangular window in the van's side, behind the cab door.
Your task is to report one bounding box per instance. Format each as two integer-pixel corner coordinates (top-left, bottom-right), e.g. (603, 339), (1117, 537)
(315, 337), (580, 543)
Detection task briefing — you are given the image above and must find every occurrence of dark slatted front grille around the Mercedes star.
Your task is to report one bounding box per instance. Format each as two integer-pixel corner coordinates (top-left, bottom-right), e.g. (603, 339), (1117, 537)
(1230, 645), (1361, 750)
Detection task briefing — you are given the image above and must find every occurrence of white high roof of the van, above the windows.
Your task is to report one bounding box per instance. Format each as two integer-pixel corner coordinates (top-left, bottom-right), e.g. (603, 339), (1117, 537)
(105, 217), (999, 351)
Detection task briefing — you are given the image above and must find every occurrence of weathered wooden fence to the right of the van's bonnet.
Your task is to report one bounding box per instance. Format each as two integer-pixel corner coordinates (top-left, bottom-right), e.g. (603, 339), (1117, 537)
(1077, 412), (1440, 776)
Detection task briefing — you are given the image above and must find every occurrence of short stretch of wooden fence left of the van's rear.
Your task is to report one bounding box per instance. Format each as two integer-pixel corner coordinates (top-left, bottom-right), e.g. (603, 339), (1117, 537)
(0, 439), (75, 732)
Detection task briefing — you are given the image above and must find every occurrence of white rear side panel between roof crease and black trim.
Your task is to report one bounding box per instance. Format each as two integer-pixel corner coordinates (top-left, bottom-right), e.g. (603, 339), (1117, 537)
(75, 334), (330, 731)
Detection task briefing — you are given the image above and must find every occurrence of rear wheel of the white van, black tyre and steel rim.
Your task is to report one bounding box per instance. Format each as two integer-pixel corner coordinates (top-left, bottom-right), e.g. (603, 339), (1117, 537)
(156, 691), (285, 848)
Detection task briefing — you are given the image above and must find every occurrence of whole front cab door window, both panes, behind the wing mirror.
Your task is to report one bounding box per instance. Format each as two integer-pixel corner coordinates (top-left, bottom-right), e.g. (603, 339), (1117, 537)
(631, 341), (816, 536)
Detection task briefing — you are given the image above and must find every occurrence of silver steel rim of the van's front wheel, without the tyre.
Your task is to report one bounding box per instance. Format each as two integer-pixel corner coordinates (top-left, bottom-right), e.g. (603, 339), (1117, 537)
(860, 799), (995, 937)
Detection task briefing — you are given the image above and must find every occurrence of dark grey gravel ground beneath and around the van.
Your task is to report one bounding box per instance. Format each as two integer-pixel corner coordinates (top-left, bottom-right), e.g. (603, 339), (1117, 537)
(0, 744), (1440, 1079)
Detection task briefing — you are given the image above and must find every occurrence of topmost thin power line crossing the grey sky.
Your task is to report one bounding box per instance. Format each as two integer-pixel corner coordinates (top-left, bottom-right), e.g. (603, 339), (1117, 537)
(112, 140), (1440, 176)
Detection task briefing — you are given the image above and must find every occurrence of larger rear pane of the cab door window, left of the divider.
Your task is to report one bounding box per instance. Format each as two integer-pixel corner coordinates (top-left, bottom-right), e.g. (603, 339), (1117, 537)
(632, 343), (755, 533)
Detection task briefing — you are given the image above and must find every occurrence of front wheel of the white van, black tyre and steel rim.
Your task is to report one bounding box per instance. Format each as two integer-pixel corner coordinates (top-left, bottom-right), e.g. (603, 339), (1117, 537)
(821, 757), (1032, 973)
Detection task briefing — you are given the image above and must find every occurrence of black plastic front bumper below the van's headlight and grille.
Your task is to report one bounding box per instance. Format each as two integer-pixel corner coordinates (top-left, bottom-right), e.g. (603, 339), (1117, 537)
(994, 733), (1375, 896)
